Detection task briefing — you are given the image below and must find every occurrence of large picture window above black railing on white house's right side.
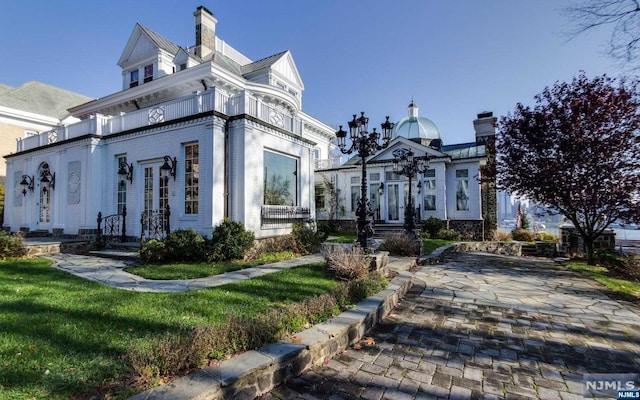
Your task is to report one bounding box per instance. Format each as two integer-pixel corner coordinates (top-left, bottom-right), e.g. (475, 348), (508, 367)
(264, 150), (298, 206)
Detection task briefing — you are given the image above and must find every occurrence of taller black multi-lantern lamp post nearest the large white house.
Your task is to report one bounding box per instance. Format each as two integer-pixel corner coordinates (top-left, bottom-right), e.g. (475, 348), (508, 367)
(336, 111), (393, 250)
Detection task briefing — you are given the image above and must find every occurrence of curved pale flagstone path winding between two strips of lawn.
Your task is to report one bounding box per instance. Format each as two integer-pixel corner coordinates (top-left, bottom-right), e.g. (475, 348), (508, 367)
(44, 253), (324, 293)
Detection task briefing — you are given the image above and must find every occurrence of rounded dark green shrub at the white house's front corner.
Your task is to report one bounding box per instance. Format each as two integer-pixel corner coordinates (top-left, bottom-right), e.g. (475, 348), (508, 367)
(206, 218), (255, 261)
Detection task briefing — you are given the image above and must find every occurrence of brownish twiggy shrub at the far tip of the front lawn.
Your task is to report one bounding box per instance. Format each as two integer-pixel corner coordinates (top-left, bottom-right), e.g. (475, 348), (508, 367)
(323, 245), (371, 281)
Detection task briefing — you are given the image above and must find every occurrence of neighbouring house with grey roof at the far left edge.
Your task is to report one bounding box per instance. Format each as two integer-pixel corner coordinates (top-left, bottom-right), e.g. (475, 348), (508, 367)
(0, 81), (93, 179)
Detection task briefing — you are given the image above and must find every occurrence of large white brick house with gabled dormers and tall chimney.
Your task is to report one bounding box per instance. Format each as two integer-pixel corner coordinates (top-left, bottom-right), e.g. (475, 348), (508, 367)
(4, 7), (334, 238)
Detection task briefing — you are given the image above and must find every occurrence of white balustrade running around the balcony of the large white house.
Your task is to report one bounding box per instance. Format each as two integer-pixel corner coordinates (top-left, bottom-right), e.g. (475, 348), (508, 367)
(16, 87), (303, 152)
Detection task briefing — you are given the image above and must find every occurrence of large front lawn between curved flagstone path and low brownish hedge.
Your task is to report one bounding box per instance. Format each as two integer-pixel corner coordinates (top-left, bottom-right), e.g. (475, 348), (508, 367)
(0, 259), (337, 400)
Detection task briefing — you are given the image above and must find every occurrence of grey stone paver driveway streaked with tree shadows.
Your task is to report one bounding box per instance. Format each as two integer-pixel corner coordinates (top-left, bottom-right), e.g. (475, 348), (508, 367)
(264, 253), (640, 400)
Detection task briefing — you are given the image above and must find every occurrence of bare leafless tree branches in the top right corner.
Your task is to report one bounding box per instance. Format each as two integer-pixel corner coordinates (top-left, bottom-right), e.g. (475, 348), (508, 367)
(564, 0), (640, 70)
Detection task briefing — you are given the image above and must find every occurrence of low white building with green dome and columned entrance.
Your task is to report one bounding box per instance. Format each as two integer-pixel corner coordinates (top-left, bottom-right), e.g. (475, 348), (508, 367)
(316, 102), (497, 240)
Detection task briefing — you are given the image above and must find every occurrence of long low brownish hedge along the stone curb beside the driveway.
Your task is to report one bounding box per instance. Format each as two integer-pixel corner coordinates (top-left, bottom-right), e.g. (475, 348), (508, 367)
(127, 273), (388, 386)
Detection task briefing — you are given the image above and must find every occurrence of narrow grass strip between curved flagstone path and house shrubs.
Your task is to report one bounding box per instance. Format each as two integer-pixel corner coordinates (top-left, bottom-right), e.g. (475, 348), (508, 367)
(126, 251), (297, 280)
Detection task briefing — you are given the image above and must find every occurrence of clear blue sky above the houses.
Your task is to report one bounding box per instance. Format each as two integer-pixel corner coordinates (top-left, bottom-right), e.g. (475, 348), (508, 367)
(0, 0), (624, 144)
